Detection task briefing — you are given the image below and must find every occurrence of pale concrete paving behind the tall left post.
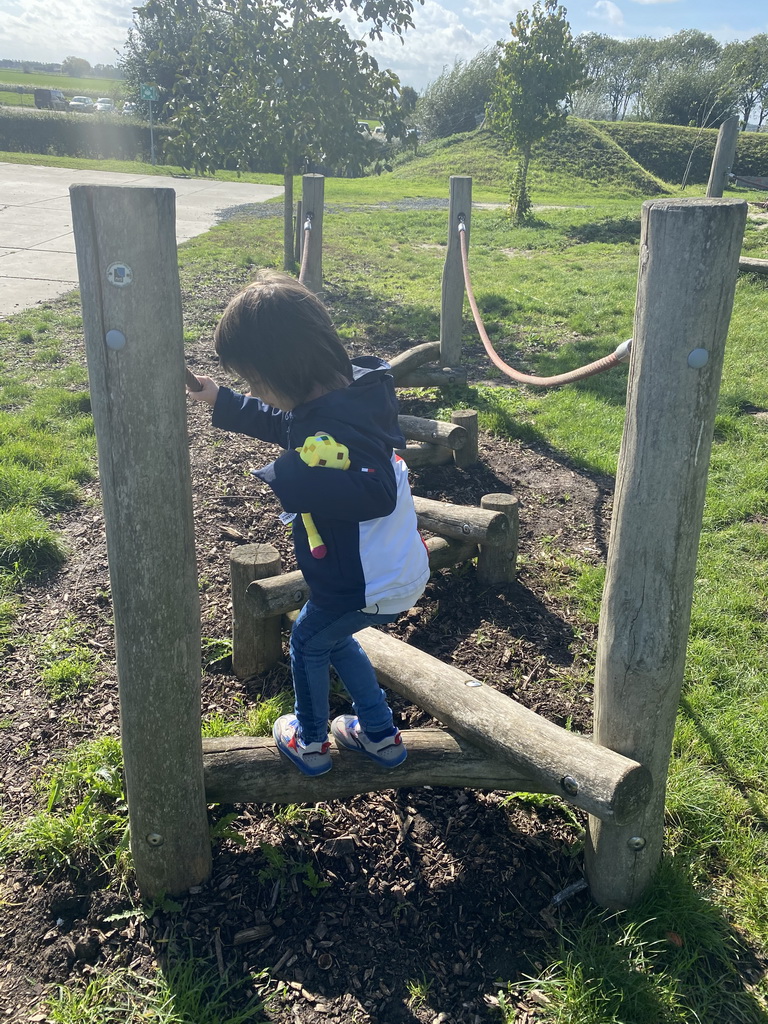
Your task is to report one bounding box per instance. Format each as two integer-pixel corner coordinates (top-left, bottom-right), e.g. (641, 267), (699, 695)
(0, 163), (283, 316)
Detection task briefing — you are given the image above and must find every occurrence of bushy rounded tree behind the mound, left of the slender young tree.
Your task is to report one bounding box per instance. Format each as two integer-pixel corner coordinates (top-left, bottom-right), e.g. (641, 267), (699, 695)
(415, 48), (497, 138)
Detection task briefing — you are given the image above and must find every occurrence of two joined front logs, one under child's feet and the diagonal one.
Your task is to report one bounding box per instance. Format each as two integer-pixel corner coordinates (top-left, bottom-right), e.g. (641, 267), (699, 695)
(204, 629), (652, 824)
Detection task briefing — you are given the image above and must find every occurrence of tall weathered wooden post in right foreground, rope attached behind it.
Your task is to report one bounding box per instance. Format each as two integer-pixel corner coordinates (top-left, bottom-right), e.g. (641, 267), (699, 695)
(587, 199), (746, 907)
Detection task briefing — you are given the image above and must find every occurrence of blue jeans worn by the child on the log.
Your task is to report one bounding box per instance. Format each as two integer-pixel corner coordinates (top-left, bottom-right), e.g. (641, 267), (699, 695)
(291, 601), (397, 743)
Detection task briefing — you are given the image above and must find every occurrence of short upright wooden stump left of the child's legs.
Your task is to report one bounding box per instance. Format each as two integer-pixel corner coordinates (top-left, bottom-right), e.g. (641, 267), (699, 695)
(229, 544), (283, 679)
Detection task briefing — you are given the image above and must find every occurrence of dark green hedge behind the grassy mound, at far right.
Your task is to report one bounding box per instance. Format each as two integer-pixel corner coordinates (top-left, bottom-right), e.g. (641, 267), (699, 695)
(591, 121), (768, 184)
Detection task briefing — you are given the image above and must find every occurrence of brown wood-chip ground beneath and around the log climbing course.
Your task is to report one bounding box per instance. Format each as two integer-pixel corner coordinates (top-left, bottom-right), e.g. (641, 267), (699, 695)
(0, 282), (612, 1024)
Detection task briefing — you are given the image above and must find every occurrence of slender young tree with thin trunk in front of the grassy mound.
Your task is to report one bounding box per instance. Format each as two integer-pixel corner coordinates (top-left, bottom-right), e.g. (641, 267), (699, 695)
(489, 0), (585, 223)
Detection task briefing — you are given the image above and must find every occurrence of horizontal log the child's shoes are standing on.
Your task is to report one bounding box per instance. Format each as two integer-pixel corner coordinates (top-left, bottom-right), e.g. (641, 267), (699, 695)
(203, 729), (552, 804)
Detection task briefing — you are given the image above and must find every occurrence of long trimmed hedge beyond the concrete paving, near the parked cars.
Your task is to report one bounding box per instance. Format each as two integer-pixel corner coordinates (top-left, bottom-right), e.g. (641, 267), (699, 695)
(0, 109), (175, 163)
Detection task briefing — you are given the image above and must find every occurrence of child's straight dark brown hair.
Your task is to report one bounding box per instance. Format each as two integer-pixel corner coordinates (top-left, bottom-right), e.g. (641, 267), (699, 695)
(214, 270), (352, 406)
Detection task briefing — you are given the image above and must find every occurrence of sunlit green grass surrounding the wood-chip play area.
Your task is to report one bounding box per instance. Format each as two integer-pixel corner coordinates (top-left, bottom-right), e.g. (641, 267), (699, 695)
(0, 125), (768, 1024)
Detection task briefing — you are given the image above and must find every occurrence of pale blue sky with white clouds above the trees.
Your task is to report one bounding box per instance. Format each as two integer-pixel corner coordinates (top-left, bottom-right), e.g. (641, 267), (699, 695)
(0, 0), (768, 90)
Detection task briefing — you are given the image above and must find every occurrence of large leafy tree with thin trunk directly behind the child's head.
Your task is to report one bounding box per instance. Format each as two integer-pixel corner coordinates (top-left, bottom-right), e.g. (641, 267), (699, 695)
(133, 0), (423, 268)
